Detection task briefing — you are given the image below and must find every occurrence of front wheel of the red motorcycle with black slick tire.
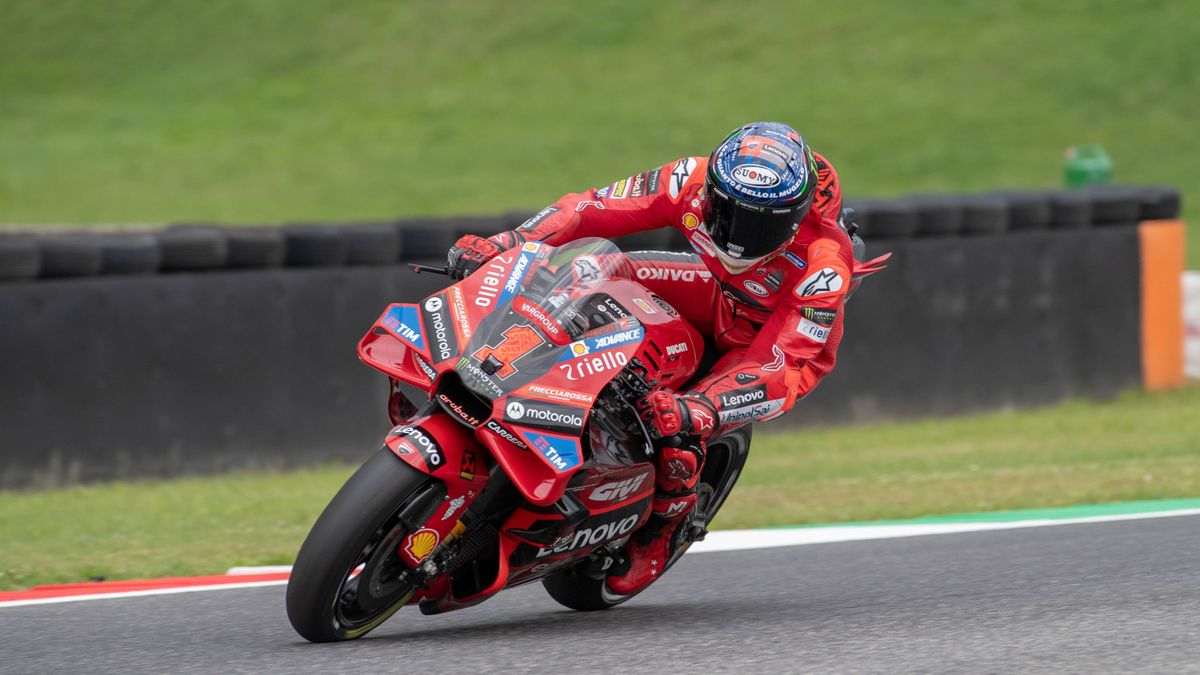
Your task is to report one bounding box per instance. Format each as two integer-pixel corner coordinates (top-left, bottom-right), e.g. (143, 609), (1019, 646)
(287, 448), (436, 643)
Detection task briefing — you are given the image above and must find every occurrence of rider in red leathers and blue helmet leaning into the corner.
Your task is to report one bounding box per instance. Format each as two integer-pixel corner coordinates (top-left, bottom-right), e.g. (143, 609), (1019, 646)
(449, 123), (884, 595)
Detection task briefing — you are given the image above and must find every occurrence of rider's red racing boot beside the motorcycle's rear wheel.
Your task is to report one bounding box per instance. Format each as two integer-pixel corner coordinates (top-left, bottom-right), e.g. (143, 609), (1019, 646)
(608, 448), (703, 596)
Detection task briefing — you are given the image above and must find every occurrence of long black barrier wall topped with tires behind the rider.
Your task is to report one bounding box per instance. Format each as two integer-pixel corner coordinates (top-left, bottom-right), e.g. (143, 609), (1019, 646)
(0, 187), (1182, 488)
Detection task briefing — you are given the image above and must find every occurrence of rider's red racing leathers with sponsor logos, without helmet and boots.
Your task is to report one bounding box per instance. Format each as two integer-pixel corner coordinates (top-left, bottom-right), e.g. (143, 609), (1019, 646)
(463, 155), (870, 432)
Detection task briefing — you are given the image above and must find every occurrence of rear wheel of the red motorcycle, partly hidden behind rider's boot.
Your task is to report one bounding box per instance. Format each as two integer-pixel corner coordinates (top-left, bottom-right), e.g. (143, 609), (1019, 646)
(541, 425), (751, 611)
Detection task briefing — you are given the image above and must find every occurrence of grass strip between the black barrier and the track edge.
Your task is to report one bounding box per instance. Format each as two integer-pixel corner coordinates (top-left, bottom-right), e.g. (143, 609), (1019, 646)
(0, 386), (1200, 589)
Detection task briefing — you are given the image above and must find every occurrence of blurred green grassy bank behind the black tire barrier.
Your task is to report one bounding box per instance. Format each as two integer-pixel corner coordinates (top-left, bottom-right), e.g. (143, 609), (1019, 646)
(0, 0), (1200, 267)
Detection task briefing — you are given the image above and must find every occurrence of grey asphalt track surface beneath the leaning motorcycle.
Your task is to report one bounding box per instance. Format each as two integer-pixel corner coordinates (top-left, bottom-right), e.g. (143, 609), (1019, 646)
(0, 516), (1200, 674)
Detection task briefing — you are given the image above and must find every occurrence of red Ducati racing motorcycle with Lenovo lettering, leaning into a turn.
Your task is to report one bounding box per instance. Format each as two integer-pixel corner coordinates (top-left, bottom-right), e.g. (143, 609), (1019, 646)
(287, 239), (750, 643)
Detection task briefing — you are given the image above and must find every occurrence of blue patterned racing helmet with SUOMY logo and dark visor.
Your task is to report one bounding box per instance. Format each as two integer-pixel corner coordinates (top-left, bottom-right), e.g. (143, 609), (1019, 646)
(703, 121), (817, 273)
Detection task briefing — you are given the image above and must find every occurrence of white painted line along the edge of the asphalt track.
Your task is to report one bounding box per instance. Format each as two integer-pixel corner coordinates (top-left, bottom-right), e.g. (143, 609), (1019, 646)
(0, 508), (1200, 608)
